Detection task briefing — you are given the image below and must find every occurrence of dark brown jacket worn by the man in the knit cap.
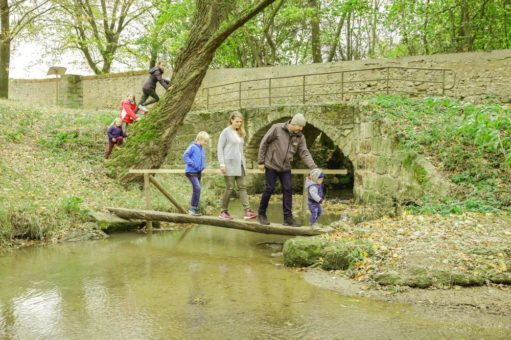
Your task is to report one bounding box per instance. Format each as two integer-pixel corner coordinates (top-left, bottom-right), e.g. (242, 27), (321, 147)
(257, 122), (318, 172)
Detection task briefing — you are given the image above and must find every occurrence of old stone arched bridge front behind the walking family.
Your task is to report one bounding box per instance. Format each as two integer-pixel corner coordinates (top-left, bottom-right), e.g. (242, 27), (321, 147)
(166, 104), (447, 205)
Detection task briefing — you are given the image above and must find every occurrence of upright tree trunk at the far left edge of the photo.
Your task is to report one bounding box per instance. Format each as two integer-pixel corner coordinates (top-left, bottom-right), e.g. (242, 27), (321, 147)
(0, 0), (11, 98)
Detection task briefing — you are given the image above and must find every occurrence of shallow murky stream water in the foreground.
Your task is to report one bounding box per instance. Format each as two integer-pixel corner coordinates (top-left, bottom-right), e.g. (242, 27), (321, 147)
(0, 226), (509, 339)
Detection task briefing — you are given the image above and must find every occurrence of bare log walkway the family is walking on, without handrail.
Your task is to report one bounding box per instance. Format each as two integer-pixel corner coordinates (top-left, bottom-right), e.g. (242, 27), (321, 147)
(107, 208), (333, 236)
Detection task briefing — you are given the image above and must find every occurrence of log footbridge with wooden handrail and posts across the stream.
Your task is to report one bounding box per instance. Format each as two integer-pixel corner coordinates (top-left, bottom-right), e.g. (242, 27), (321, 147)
(116, 169), (347, 236)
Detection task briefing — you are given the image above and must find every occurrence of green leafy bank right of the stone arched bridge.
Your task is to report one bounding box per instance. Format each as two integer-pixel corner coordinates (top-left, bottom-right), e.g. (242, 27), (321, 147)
(372, 96), (511, 213)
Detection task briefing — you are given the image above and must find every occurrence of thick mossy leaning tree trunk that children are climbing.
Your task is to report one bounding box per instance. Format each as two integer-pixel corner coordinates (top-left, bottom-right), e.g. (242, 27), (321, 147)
(107, 0), (275, 182)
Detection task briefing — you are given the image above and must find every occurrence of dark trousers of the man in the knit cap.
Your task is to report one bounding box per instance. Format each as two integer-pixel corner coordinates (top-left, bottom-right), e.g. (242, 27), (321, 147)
(259, 168), (293, 218)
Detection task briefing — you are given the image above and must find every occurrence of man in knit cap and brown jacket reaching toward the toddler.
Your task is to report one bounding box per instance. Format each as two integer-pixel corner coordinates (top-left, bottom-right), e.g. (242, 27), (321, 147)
(257, 113), (318, 227)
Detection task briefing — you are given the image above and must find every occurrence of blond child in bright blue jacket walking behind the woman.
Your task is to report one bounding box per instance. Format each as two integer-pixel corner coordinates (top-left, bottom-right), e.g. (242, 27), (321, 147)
(183, 131), (209, 216)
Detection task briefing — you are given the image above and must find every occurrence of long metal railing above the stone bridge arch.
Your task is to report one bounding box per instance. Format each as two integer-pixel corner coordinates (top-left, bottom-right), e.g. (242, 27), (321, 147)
(197, 66), (456, 110)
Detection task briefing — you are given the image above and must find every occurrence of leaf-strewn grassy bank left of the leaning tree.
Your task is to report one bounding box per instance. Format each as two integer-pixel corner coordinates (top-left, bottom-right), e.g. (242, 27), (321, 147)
(0, 100), (216, 247)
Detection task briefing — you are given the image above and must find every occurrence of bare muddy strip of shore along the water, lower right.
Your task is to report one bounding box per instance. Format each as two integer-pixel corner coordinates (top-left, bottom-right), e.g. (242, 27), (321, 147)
(303, 269), (511, 331)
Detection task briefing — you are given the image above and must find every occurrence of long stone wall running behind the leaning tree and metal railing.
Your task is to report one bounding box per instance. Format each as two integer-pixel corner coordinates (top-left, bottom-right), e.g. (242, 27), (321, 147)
(9, 49), (511, 110)
